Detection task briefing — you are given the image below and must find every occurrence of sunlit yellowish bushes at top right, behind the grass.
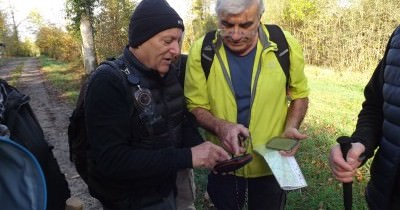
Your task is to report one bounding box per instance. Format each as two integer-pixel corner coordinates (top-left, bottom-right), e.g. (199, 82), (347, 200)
(265, 0), (400, 72)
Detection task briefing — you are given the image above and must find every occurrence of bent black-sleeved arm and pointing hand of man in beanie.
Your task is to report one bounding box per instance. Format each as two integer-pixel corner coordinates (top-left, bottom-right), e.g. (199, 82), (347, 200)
(85, 69), (230, 180)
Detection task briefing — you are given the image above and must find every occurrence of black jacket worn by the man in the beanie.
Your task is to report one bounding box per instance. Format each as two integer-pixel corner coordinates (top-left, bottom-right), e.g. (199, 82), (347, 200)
(85, 48), (192, 206)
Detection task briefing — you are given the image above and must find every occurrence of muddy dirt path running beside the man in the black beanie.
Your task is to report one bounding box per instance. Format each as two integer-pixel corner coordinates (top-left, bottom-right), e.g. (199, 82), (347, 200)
(0, 58), (102, 210)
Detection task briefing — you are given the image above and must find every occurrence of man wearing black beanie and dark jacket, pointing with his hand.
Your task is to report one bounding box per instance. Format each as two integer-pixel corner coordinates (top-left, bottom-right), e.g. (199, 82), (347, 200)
(84, 0), (230, 210)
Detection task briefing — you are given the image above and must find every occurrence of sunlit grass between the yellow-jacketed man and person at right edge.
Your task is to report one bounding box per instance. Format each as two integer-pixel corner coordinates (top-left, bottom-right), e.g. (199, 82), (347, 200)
(286, 67), (370, 209)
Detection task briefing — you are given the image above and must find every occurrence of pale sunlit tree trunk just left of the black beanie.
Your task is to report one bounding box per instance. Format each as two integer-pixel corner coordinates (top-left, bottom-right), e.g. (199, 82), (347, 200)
(80, 14), (97, 74)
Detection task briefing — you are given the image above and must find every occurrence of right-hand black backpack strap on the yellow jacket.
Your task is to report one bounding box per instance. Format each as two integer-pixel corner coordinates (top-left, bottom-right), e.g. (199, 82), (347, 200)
(265, 24), (290, 88)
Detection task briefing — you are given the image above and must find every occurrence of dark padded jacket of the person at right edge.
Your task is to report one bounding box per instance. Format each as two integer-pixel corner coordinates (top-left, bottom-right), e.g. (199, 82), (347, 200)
(352, 26), (400, 209)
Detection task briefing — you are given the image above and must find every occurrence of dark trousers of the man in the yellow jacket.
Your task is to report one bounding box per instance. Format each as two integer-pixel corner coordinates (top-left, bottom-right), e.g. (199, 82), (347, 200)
(207, 173), (286, 210)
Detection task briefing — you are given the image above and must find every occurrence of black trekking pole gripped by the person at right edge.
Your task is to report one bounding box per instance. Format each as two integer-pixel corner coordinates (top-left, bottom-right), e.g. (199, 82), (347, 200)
(336, 136), (353, 210)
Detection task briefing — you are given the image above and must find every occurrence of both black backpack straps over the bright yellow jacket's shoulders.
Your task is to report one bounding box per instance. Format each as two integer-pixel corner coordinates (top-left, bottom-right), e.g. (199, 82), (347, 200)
(201, 24), (290, 87)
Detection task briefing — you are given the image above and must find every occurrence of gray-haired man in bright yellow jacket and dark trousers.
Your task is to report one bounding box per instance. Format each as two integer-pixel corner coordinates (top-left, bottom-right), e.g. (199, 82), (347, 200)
(184, 0), (309, 210)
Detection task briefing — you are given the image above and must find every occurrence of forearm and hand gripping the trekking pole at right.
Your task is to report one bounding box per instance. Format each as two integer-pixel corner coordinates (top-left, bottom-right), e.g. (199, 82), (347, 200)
(329, 61), (383, 182)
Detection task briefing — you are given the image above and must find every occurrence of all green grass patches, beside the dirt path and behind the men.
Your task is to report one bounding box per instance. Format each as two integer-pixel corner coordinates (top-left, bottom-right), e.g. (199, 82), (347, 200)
(41, 57), (371, 210)
